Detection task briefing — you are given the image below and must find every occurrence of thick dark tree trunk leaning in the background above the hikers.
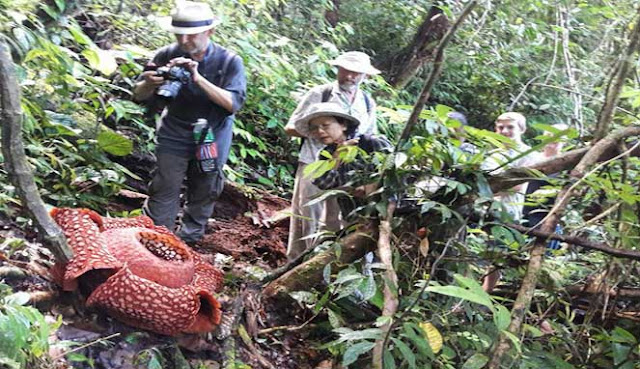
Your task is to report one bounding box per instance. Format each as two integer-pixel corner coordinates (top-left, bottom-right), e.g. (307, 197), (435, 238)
(380, 6), (449, 88)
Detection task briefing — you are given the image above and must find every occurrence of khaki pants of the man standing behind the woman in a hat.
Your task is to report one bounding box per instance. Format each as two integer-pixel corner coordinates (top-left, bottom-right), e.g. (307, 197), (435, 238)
(287, 162), (341, 260)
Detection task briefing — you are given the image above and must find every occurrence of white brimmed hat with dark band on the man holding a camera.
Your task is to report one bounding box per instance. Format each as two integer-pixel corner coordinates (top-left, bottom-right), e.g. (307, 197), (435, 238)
(158, 1), (220, 35)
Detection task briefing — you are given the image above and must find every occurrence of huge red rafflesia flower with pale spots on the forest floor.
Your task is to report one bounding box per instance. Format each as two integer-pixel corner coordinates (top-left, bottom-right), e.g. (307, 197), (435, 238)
(51, 208), (223, 335)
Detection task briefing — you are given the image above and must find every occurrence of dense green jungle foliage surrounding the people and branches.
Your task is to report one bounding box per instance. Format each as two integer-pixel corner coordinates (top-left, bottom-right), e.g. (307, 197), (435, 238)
(0, 0), (640, 369)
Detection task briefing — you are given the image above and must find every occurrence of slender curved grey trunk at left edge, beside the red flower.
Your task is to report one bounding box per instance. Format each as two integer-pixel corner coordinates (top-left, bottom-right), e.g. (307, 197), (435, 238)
(0, 40), (73, 263)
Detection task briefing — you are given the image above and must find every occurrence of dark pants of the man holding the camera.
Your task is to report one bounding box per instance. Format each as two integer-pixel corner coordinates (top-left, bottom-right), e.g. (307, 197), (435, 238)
(143, 152), (224, 243)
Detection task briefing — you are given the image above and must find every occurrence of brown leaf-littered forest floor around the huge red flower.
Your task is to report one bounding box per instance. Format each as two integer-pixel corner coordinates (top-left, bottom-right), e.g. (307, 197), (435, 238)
(0, 178), (332, 369)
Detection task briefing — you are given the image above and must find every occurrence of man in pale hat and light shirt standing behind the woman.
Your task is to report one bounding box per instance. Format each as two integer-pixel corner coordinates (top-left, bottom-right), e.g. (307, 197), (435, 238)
(285, 51), (380, 259)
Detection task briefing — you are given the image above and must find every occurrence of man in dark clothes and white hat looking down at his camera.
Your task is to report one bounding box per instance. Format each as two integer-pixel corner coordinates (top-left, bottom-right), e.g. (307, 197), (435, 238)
(133, 1), (246, 244)
